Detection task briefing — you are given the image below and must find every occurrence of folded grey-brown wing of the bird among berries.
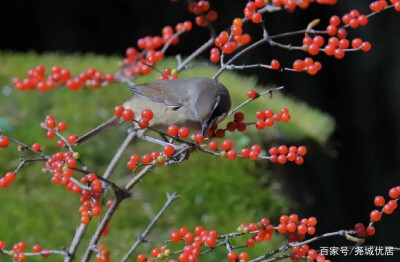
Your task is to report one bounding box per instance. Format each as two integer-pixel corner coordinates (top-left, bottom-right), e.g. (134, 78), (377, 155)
(130, 80), (184, 109)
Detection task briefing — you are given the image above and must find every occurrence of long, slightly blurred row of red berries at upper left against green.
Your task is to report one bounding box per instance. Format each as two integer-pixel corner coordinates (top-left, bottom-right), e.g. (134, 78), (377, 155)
(13, 65), (114, 92)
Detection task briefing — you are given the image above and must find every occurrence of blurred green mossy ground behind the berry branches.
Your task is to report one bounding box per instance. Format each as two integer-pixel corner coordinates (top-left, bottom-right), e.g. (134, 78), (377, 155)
(0, 53), (334, 261)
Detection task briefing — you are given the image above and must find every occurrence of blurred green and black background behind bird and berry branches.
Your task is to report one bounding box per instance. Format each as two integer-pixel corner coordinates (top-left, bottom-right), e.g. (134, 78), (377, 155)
(0, 0), (400, 261)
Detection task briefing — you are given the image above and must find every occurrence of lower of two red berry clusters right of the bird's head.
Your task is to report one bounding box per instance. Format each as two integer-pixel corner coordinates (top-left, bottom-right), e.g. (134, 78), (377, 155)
(269, 145), (307, 165)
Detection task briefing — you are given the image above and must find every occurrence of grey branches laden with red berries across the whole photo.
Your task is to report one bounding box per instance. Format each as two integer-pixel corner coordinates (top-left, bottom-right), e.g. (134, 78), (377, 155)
(0, 0), (400, 262)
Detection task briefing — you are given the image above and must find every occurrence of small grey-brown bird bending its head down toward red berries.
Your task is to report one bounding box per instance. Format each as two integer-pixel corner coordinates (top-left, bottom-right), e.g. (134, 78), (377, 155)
(74, 77), (231, 145)
